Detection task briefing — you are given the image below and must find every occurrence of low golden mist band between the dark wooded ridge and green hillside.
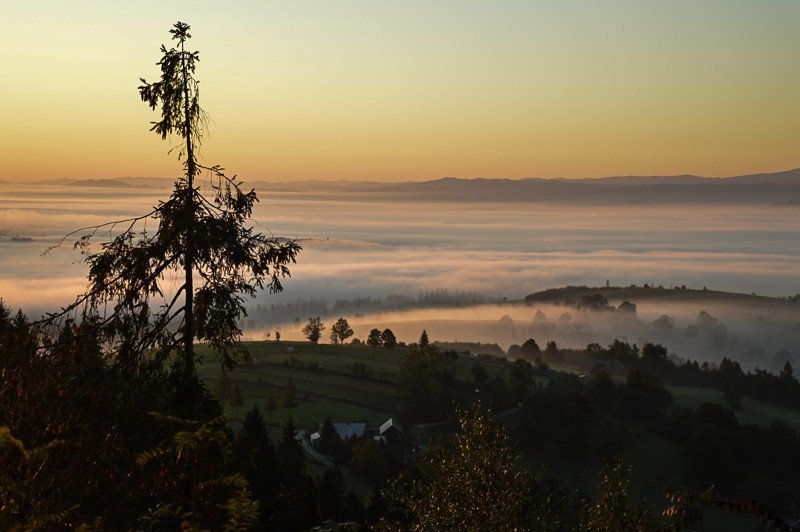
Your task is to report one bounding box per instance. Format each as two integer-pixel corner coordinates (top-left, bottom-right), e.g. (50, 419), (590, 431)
(246, 288), (800, 372)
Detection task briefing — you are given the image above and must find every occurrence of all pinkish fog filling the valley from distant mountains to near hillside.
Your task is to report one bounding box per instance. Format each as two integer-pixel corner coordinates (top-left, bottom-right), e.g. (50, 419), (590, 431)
(0, 170), (800, 369)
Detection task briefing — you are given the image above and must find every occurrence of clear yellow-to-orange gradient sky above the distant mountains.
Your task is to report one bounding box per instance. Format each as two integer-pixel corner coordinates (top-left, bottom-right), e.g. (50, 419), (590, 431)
(0, 0), (800, 181)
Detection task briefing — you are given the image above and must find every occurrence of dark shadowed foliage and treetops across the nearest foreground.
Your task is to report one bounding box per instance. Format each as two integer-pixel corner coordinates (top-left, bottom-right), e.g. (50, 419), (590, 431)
(0, 304), (789, 530)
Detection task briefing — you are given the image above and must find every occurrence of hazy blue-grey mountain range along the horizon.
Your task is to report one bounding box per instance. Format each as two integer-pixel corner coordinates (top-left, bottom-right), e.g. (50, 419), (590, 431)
(14, 168), (800, 205)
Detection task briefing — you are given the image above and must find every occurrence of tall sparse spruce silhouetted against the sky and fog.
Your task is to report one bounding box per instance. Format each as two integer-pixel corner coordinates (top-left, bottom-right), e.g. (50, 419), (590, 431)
(51, 22), (301, 399)
